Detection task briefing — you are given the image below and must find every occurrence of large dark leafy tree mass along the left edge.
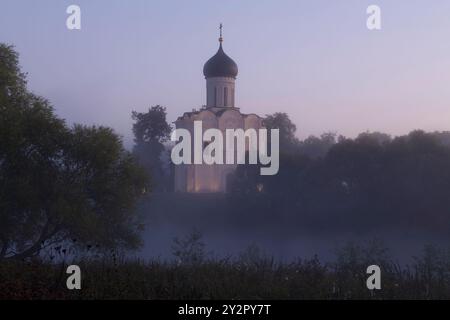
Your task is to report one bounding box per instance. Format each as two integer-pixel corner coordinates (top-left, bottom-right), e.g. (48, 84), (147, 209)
(0, 45), (147, 260)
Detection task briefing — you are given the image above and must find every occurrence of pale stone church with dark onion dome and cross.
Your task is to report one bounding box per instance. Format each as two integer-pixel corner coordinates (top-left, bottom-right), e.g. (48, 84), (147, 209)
(175, 25), (263, 193)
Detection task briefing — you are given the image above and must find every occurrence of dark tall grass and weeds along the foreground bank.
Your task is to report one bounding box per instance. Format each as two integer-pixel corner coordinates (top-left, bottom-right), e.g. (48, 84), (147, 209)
(0, 237), (450, 299)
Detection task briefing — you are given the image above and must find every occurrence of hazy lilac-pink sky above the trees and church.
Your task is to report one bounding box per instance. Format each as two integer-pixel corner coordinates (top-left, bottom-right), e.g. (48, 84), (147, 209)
(0, 0), (450, 146)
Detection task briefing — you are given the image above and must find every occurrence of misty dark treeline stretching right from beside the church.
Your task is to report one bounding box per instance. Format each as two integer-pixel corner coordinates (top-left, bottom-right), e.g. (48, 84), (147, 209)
(229, 114), (450, 233)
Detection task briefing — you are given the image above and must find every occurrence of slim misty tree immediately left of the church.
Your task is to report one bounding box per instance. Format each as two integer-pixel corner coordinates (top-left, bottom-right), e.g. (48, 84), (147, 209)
(131, 105), (173, 190)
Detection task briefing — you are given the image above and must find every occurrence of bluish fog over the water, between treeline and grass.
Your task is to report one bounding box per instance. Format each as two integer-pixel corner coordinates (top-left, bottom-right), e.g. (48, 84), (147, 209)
(137, 194), (450, 264)
